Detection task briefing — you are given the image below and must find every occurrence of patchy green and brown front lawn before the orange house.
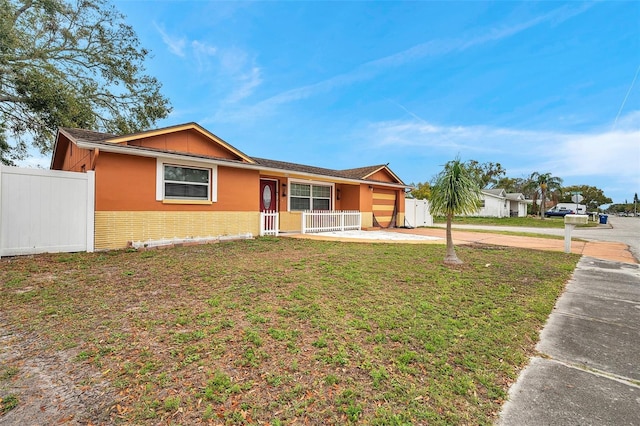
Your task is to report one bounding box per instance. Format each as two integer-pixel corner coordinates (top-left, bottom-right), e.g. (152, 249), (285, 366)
(0, 238), (579, 425)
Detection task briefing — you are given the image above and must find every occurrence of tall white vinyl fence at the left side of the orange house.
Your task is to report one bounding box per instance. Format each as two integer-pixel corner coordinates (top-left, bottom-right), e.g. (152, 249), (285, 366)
(0, 166), (95, 256)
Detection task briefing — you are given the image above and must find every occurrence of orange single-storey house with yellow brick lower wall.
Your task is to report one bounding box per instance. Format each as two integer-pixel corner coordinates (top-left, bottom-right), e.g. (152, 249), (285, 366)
(51, 123), (407, 250)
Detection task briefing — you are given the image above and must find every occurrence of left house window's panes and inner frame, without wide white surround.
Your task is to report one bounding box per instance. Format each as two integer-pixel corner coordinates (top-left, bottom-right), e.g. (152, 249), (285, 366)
(164, 164), (210, 200)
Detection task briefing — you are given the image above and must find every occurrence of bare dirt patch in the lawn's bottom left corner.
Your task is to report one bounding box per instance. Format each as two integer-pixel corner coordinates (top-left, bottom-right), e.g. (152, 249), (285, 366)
(0, 315), (116, 425)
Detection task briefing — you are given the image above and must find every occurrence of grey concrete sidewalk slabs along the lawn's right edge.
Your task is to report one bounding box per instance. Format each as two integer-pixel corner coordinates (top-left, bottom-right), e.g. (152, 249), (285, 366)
(498, 257), (640, 426)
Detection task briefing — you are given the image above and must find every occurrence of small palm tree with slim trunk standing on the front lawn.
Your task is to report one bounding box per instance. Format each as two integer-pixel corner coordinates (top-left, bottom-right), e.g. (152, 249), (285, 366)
(429, 158), (481, 264)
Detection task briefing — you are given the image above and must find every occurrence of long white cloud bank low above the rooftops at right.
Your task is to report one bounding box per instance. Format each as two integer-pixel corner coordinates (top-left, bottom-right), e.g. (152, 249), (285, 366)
(359, 111), (640, 182)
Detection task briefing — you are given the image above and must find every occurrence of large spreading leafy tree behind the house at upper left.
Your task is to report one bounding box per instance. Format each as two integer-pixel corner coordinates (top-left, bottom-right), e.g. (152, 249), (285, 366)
(0, 0), (171, 164)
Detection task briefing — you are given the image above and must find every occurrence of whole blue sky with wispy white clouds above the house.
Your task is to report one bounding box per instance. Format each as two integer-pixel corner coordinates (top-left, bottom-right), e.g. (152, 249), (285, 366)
(26, 0), (640, 203)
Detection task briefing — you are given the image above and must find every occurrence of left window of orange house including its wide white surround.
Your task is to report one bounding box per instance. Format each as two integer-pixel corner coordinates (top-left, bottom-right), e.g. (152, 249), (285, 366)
(156, 159), (217, 204)
